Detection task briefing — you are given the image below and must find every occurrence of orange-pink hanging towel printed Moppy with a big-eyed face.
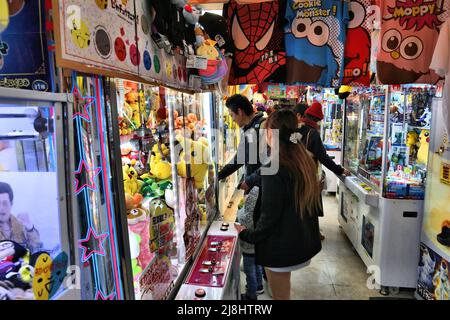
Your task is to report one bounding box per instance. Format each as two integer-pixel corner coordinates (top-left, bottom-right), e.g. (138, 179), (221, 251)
(377, 0), (450, 84)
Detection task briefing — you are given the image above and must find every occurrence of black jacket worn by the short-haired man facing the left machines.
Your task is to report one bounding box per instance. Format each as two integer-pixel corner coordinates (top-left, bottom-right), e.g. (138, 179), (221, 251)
(219, 112), (265, 189)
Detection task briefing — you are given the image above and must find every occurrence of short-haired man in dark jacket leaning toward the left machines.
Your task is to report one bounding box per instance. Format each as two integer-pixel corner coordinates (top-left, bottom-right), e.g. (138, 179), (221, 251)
(219, 94), (265, 192)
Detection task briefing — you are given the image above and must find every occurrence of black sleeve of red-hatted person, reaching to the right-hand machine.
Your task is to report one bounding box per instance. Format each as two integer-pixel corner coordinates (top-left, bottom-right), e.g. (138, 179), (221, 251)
(300, 125), (344, 176)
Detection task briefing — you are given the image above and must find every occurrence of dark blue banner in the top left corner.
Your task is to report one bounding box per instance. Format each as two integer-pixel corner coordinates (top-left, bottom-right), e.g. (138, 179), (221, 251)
(0, 0), (50, 91)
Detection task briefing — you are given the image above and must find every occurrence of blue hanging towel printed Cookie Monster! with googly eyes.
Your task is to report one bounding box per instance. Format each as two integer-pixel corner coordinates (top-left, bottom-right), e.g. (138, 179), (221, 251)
(285, 0), (349, 87)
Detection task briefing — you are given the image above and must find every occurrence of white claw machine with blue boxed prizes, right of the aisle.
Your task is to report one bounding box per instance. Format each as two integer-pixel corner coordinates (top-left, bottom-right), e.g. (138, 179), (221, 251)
(339, 86), (434, 294)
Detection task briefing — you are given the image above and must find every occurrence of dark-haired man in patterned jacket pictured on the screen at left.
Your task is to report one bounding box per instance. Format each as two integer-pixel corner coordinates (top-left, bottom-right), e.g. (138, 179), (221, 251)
(0, 182), (42, 253)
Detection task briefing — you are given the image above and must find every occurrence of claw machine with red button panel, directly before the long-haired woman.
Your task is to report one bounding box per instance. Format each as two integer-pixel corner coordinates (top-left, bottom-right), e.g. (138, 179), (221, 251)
(175, 93), (240, 300)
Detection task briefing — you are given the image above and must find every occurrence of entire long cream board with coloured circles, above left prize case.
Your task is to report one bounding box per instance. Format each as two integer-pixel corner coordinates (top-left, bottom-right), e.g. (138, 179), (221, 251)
(54, 0), (188, 88)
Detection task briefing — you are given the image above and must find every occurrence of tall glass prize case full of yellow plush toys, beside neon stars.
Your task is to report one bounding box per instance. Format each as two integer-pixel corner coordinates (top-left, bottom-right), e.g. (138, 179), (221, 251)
(109, 79), (184, 300)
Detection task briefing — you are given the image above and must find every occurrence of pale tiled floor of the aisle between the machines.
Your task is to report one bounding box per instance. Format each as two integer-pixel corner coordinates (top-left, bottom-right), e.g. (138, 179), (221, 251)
(225, 192), (413, 300)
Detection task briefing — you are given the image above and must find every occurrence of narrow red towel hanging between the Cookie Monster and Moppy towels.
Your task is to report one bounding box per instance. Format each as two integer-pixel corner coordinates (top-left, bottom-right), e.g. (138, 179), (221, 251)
(342, 0), (373, 87)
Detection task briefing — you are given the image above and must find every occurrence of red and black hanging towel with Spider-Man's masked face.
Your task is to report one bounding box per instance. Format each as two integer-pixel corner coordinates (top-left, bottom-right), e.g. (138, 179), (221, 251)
(224, 0), (286, 85)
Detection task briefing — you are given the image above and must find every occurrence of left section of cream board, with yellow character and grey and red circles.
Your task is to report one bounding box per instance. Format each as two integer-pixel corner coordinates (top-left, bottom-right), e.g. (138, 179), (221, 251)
(55, 0), (140, 75)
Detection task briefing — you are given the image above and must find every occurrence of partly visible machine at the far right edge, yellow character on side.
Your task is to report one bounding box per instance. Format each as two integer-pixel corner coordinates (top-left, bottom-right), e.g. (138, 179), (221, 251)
(416, 95), (450, 300)
